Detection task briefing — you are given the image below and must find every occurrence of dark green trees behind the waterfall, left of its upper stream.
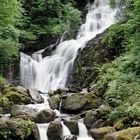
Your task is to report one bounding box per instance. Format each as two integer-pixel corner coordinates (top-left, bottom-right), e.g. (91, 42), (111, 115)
(18, 0), (81, 44)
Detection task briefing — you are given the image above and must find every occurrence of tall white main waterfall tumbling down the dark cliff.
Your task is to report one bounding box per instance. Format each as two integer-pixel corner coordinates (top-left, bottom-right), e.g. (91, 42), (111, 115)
(20, 0), (117, 92)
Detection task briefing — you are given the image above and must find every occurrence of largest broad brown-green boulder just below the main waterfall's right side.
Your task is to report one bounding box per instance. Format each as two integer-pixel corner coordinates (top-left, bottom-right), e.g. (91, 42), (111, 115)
(62, 93), (101, 112)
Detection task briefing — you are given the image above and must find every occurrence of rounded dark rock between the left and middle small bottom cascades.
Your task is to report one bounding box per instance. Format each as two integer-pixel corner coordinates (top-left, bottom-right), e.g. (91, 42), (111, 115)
(47, 122), (63, 140)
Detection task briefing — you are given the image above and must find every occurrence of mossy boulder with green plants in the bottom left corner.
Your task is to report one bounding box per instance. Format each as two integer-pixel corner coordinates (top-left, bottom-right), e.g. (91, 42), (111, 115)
(0, 118), (39, 140)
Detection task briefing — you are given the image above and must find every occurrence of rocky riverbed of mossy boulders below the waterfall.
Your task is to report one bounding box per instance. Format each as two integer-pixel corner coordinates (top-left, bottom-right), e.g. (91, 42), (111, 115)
(0, 85), (140, 140)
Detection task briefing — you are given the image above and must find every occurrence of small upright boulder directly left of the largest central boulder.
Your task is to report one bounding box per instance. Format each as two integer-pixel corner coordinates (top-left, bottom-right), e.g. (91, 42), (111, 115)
(48, 94), (61, 109)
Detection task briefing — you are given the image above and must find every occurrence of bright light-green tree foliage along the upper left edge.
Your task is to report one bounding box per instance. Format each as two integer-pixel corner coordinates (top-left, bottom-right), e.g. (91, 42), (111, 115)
(0, 0), (22, 67)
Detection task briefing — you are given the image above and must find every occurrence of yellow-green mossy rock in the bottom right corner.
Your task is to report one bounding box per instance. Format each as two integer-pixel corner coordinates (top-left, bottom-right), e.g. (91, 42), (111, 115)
(104, 127), (140, 140)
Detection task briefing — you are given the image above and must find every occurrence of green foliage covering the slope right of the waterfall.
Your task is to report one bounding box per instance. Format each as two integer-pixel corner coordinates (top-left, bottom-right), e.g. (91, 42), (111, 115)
(97, 0), (140, 121)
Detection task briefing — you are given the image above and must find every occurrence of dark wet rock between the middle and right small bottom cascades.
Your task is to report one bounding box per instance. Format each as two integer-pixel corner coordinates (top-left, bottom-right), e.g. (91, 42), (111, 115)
(64, 119), (79, 135)
